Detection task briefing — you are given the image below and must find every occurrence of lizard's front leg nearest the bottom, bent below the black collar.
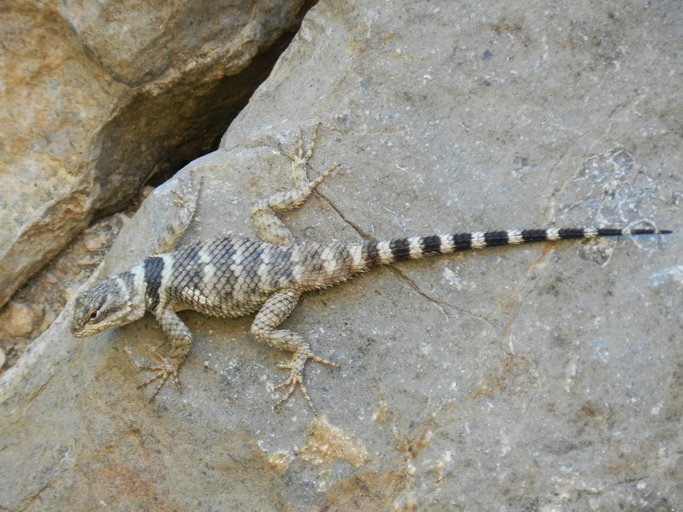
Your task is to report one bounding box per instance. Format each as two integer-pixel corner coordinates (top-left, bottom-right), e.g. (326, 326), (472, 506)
(138, 309), (192, 401)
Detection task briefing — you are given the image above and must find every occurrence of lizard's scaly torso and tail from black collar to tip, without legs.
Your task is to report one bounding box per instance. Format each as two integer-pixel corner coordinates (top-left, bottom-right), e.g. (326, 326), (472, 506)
(154, 228), (665, 317)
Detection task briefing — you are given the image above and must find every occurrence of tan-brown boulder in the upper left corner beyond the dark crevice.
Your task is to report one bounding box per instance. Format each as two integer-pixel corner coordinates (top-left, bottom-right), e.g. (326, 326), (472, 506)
(0, 0), (305, 306)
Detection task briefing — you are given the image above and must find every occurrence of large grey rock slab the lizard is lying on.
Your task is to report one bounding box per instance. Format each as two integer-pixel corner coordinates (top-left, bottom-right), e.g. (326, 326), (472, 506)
(0, 0), (683, 512)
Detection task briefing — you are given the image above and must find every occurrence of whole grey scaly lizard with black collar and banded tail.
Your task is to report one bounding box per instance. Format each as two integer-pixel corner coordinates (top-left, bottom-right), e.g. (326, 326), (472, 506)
(71, 125), (671, 413)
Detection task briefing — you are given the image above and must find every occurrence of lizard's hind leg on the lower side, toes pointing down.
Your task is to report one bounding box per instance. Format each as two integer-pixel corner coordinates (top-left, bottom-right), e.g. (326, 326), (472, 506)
(251, 290), (339, 412)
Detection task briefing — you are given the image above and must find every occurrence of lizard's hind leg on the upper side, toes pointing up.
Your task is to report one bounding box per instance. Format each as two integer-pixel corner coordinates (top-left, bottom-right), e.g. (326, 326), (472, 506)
(251, 124), (337, 245)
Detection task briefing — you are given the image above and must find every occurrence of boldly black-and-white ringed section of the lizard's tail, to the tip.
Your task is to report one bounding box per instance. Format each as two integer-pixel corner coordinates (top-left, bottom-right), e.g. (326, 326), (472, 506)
(363, 228), (671, 267)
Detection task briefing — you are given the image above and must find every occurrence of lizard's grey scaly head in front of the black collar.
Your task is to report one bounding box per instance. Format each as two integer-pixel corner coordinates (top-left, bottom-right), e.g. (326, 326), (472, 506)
(71, 272), (145, 338)
